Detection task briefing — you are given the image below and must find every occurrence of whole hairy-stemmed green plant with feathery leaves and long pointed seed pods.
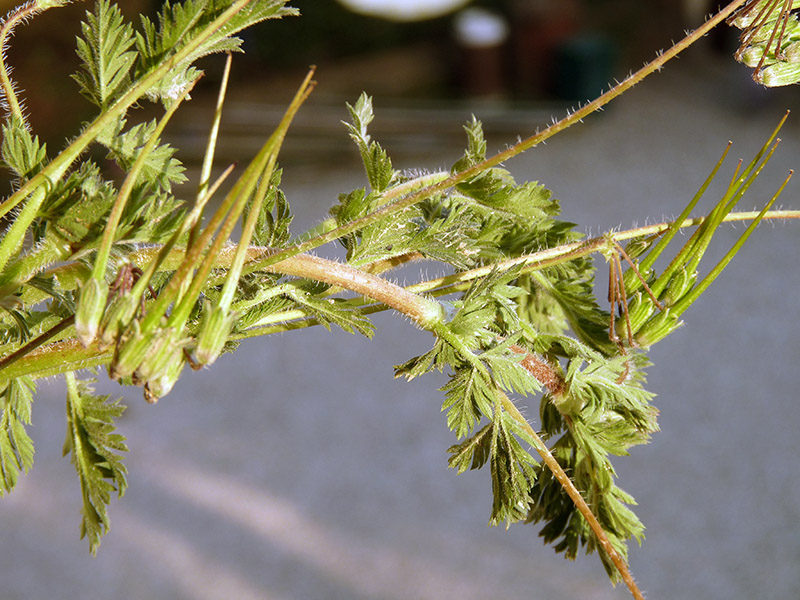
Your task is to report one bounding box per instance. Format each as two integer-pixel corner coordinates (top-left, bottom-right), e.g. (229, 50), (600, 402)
(0, 0), (800, 597)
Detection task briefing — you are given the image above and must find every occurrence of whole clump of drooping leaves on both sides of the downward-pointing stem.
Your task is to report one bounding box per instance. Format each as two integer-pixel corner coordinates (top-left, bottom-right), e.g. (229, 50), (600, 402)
(396, 258), (657, 578)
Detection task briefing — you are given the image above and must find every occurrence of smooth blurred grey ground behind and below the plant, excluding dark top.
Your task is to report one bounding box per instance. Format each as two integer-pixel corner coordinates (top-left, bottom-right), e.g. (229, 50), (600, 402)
(0, 45), (800, 600)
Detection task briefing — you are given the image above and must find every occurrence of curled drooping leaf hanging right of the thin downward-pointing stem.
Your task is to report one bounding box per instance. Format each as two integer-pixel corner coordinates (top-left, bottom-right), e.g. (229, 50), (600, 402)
(527, 342), (658, 578)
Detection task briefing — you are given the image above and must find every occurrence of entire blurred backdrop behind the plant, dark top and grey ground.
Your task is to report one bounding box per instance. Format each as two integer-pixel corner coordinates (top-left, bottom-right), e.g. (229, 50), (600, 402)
(0, 0), (800, 600)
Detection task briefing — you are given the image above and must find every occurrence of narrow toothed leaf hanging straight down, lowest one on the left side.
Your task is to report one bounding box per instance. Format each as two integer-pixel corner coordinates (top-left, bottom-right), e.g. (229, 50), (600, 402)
(64, 374), (128, 554)
